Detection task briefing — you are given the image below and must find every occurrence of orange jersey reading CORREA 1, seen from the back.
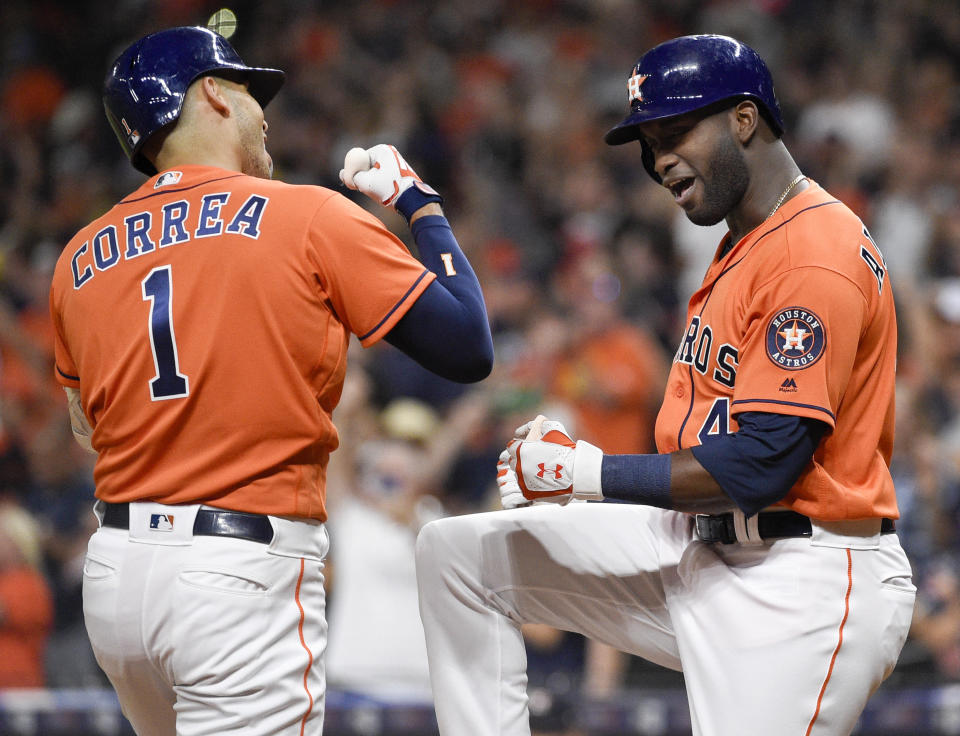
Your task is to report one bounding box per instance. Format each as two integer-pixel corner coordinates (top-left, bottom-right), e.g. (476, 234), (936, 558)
(50, 166), (435, 520)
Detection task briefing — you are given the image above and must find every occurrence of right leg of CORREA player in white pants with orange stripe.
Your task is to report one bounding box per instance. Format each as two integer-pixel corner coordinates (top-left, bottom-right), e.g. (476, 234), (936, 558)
(167, 538), (327, 736)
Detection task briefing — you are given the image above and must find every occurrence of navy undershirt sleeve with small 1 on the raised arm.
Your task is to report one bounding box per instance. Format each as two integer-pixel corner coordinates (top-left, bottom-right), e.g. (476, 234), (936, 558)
(384, 215), (493, 383)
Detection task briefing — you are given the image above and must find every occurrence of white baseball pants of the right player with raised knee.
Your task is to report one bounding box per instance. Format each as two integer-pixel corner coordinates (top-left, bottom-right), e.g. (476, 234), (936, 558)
(417, 503), (916, 736)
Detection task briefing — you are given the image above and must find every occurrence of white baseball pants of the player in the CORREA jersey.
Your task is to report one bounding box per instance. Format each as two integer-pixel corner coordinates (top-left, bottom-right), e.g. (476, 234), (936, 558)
(83, 503), (328, 736)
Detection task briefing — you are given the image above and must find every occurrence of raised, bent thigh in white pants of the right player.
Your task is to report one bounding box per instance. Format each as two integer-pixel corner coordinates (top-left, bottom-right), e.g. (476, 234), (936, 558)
(418, 503), (690, 668)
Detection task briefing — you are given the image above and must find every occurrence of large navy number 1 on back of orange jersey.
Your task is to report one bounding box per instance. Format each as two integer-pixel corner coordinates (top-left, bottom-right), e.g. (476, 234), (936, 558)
(140, 266), (190, 401)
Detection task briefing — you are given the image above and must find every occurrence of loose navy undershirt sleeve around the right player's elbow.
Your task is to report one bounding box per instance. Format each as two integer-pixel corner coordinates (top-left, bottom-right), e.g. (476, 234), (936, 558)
(692, 412), (829, 516)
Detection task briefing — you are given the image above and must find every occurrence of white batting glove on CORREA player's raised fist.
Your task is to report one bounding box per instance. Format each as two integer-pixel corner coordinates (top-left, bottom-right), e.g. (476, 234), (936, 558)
(340, 143), (440, 213)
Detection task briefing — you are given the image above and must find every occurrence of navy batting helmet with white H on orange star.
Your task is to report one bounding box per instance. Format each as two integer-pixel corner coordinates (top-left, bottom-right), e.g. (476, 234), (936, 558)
(604, 35), (783, 181)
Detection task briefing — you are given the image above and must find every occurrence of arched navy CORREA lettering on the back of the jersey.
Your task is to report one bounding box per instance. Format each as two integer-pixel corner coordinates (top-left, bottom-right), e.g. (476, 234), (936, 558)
(70, 192), (269, 289)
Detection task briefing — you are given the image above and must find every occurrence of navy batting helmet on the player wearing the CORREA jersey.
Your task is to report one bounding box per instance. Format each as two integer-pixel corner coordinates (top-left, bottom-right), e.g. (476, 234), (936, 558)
(103, 27), (284, 176)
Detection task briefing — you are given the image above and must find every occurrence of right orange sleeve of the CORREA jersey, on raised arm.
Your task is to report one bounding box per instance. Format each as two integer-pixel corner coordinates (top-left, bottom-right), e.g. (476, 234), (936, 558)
(309, 194), (436, 347)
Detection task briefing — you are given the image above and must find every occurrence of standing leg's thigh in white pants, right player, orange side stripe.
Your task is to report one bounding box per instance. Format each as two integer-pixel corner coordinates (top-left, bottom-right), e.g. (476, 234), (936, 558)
(667, 539), (912, 736)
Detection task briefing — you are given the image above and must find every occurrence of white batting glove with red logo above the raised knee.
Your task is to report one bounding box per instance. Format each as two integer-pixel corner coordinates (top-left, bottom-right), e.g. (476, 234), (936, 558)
(497, 419), (603, 507)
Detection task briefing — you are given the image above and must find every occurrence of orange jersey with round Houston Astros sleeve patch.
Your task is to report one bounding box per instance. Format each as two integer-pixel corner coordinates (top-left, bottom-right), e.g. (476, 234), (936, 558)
(656, 182), (898, 521)
